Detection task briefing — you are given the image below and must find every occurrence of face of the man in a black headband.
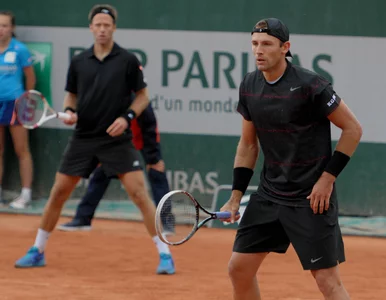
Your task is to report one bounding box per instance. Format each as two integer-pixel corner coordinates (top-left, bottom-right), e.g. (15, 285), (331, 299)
(90, 14), (116, 45)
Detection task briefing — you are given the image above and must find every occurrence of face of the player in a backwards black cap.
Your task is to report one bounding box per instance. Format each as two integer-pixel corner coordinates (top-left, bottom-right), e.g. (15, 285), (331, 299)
(252, 32), (289, 72)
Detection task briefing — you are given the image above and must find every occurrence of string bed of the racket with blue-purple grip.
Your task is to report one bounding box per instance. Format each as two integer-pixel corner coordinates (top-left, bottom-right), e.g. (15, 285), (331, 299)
(159, 193), (198, 243)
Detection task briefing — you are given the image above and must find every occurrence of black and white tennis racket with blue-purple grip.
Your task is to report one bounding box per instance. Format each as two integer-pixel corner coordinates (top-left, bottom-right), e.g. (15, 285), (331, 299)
(155, 190), (238, 246)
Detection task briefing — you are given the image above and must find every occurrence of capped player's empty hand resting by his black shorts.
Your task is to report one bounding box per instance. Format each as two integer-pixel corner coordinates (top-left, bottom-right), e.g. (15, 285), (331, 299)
(307, 172), (335, 214)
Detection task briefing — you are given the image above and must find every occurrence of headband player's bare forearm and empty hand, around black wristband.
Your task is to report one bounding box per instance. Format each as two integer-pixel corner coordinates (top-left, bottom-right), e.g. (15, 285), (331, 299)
(106, 88), (149, 137)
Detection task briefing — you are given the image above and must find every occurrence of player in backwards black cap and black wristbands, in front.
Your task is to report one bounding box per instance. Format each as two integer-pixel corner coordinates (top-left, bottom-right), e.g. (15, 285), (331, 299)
(222, 18), (362, 300)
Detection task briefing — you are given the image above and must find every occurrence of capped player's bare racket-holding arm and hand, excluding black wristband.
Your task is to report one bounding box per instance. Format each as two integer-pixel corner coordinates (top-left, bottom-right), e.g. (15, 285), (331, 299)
(221, 119), (259, 223)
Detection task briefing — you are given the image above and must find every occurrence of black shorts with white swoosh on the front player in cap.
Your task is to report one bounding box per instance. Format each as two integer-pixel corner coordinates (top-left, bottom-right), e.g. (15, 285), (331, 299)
(233, 194), (345, 270)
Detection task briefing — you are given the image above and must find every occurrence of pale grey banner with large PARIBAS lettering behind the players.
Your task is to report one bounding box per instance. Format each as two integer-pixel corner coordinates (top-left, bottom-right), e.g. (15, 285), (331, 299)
(17, 26), (386, 142)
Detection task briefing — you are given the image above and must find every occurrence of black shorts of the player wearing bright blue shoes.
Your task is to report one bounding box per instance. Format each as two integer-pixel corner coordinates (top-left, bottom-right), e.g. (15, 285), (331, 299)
(59, 136), (142, 178)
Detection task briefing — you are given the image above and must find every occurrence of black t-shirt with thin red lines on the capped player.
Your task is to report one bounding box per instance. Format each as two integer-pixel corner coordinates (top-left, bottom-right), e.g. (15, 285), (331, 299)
(238, 62), (341, 206)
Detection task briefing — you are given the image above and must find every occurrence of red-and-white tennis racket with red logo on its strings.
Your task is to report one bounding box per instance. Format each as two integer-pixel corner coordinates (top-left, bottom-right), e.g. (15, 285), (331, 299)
(15, 90), (71, 129)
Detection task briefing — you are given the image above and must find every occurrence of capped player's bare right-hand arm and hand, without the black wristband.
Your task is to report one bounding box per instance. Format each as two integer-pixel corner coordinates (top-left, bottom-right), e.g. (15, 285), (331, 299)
(308, 100), (362, 214)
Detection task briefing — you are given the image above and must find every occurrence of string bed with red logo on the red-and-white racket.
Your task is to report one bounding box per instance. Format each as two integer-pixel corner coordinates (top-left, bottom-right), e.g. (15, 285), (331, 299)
(15, 93), (45, 126)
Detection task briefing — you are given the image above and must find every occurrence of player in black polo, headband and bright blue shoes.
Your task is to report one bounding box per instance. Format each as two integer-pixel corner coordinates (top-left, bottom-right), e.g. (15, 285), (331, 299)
(15, 5), (175, 274)
